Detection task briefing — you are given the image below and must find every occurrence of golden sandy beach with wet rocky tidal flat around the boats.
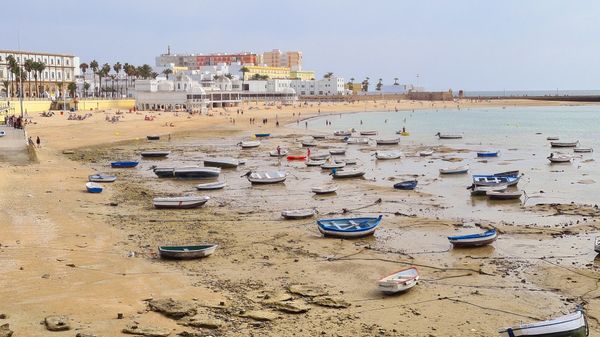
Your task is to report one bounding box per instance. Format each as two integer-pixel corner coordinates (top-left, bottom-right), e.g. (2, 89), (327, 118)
(0, 100), (600, 337)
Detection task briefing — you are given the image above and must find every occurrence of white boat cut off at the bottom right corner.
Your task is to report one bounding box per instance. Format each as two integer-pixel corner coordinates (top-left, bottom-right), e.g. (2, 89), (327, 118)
(498, 310), (590, 337)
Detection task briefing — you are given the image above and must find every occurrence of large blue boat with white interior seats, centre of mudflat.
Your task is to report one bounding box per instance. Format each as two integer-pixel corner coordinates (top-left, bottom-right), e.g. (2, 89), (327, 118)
(317, 215), (383, 238)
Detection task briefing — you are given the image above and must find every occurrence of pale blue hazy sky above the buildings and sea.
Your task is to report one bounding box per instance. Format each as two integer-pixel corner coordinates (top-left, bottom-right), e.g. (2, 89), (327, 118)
(0, 0), (600, 90)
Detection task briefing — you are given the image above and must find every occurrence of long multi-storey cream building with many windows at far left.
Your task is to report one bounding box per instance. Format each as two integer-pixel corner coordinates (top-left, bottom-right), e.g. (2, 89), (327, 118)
(0, 50), (79, 98)
